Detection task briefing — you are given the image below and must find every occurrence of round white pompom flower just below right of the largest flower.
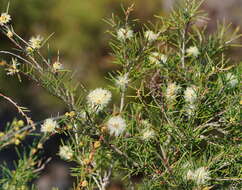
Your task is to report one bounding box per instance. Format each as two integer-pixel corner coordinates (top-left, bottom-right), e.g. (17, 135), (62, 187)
(107, 116), (126, 136)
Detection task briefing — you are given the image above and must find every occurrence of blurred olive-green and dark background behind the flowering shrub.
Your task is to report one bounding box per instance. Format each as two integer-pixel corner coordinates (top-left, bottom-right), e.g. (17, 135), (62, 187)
(0, 0), (242, 190)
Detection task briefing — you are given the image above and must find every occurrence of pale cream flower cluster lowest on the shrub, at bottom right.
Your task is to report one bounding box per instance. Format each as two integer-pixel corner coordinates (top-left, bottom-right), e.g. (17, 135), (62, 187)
(186, 167), (210, 185)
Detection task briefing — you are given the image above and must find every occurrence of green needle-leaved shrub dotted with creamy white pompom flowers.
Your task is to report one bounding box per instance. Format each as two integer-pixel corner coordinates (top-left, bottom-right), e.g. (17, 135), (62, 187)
(0, 0), (241, 190)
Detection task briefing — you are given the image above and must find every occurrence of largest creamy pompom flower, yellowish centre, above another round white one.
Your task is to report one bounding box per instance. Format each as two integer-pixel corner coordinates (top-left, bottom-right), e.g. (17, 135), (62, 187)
(87, 88), (112, 112)
